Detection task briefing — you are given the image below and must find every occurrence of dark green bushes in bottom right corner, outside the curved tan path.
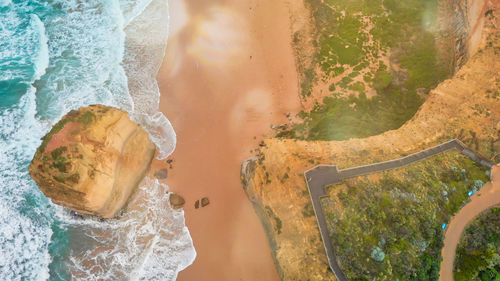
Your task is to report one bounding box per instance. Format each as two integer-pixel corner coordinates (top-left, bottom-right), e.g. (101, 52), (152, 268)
(454, 207), (500, 281)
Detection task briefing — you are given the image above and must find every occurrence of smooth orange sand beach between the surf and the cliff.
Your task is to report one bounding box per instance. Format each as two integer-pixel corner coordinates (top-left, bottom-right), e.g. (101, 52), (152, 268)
(158, 0), (300, 281)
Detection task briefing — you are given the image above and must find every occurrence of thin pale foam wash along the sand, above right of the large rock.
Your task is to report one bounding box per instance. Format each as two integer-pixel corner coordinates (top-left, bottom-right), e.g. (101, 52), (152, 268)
(124, 0), (176, 159)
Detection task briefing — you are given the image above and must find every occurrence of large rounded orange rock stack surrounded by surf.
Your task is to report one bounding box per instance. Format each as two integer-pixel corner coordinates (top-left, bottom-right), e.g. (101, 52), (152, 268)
(29, 105), (155, 218)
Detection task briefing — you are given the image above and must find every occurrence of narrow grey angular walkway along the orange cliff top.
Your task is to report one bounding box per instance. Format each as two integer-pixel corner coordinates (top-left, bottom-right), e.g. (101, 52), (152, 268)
(304, 139), (494, 281)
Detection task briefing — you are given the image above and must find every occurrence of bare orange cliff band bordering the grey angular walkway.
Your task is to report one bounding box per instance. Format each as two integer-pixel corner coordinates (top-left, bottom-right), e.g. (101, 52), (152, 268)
(241, 1), (500, 280)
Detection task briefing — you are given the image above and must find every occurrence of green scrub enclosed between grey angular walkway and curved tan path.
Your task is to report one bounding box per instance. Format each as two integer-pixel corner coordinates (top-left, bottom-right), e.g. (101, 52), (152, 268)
(322, 151), (488, 280)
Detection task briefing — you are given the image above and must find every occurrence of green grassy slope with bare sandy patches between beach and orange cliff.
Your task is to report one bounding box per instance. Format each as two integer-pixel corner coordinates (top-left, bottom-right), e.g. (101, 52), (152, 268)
(277, 0), (452, 140)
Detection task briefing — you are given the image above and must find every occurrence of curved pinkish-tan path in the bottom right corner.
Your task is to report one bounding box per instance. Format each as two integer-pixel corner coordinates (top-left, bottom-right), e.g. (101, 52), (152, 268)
(439, 164), (500, 281)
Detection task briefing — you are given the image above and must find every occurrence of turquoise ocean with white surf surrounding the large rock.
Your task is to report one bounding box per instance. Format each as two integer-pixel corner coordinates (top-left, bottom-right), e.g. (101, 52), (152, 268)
(0, 0), (196, 280)
